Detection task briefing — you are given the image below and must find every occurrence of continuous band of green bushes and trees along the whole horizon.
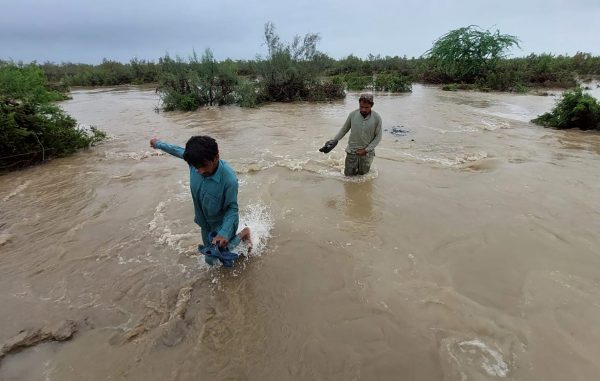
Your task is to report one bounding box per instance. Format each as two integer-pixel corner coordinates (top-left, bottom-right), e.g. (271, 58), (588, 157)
(15, 23), (600, 110)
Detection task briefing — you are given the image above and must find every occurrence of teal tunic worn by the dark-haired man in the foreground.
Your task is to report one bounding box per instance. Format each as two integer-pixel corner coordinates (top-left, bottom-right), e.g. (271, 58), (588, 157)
(155, 140), (239, 246)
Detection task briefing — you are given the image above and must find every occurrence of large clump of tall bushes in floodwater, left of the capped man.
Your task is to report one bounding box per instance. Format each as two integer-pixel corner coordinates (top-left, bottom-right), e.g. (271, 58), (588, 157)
(157, 23), (345, 111)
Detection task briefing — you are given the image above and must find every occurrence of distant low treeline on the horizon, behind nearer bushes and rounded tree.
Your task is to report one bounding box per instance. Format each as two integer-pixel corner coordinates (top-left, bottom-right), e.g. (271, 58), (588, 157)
(8, 53), (600, 91)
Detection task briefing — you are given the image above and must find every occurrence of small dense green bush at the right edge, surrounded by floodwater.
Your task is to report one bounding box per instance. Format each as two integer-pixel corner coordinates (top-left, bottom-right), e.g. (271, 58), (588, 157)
(532, 87), (600, 130)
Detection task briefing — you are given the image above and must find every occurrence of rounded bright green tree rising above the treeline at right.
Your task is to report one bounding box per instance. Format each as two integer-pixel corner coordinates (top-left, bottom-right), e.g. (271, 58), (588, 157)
(425, 25), (519, 83)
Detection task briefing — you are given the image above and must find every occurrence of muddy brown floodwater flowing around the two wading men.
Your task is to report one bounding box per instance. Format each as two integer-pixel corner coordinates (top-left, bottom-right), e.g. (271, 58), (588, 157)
(0, 86), (600, 381)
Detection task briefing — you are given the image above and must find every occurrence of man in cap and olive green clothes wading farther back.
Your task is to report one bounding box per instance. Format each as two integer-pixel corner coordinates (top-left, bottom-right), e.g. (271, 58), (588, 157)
(321, 93), (381, 176)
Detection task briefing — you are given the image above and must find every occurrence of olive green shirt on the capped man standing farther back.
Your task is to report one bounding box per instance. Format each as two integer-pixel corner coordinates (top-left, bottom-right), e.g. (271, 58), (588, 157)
(334, 109), (381, 156)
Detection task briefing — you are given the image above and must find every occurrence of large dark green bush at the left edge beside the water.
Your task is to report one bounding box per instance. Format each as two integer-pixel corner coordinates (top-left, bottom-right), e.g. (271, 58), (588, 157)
(0, 63), (105, 170)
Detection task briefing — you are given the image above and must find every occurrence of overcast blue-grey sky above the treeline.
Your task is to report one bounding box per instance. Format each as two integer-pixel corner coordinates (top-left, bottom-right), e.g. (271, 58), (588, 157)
(0, 0), (600, 63)
